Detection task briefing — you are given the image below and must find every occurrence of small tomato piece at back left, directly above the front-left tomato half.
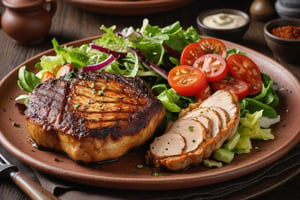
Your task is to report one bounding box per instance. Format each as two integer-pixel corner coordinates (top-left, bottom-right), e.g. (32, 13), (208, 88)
(180, 43), (205, 66)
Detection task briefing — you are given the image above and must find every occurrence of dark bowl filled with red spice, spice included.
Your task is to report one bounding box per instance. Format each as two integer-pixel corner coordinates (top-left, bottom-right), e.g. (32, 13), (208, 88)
(264, 18), (300, 63)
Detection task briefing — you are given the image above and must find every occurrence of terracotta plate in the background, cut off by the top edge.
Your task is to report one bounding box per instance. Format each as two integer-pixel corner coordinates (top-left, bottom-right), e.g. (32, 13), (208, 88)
(66, 0), (194, 15)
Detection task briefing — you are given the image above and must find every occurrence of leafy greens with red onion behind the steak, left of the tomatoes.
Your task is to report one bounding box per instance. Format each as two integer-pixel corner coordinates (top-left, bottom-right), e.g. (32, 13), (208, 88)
(18, 19), (200, 117)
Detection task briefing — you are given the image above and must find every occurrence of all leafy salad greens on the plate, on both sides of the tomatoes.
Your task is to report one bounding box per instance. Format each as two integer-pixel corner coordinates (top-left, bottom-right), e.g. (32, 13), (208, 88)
(17, 19), (279, 166)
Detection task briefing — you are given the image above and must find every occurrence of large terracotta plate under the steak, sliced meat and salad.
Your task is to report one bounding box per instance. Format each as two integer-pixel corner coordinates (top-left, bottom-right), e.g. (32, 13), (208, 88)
(0, 37), (300, 190)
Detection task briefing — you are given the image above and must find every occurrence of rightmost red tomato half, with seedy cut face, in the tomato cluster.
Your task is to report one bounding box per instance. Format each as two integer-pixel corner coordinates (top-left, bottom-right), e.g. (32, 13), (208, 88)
(227, 54), (262, 95)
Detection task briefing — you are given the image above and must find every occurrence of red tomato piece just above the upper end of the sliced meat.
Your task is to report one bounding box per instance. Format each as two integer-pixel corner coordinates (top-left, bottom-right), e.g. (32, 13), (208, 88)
(212, 76), (249, 99)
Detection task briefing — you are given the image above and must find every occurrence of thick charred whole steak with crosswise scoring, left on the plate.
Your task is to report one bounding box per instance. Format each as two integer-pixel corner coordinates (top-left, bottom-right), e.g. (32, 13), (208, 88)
(25, 72), (165, 162)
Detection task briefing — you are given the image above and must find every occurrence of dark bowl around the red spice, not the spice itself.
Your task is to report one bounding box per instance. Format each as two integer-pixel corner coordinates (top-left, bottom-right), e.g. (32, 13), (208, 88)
(264, 18), (300, 63)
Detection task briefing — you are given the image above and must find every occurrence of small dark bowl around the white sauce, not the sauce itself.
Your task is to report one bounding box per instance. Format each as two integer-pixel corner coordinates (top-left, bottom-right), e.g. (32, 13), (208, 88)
(196, 8), (250, 41)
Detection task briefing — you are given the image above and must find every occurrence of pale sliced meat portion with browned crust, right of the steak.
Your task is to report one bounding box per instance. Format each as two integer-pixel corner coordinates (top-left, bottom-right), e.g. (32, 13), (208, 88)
(146, 90), (240, 171)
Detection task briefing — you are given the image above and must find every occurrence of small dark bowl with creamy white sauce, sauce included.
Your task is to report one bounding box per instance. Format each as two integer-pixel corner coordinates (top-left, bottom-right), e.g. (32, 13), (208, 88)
(196, 8), (250, 41)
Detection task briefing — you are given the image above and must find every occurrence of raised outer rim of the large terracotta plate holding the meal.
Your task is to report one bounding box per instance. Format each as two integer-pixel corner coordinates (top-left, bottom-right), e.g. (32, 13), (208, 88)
(0, 35), (300, 190)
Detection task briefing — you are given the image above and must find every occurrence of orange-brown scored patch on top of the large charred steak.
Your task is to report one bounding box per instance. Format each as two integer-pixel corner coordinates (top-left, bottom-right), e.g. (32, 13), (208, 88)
(69, 80), (143, 137)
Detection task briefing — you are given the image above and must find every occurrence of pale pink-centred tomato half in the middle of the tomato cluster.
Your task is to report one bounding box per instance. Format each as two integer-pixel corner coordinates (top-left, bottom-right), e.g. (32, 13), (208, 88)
(193, 54), (228, 81)
